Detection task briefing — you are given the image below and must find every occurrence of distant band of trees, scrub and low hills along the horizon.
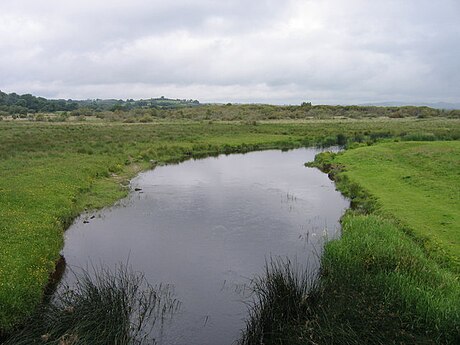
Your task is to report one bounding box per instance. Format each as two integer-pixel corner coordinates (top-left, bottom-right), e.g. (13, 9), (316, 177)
(0, 91), (460, 122)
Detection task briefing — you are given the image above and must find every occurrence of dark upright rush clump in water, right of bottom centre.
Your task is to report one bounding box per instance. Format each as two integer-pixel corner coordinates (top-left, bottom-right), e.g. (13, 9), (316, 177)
(239, 258), (317, 345)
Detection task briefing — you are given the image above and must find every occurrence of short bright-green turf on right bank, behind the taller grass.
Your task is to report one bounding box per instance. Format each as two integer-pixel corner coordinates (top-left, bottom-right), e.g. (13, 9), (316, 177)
(335, 141), (460, 273)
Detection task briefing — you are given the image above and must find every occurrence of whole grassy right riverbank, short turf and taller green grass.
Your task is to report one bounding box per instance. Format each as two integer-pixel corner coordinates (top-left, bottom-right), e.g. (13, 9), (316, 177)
(310, 141), (460, 344)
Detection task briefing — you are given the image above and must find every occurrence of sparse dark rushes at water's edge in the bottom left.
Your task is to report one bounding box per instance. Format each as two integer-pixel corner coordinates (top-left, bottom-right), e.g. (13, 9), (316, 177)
(4, 265), (180, 345)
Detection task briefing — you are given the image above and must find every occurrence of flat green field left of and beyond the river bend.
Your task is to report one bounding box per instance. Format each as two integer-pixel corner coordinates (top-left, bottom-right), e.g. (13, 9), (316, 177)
(0, 117), (460, 338)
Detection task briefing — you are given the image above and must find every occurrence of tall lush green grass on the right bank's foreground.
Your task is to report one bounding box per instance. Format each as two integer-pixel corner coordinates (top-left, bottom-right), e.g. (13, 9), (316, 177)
(315, 212), (460, 344)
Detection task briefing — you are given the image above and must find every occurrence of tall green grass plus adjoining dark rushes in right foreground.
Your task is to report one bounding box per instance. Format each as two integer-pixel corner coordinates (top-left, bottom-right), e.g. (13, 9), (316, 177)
(238, 224), (460, 345)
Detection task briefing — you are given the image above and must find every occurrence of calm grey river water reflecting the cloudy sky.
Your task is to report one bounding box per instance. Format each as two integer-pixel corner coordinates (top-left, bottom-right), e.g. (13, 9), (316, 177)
(63, 149), (348, 345)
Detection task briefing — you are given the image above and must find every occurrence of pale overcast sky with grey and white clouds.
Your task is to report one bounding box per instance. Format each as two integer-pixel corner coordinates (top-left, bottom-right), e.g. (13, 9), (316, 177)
(0, 0), (460, 104)
